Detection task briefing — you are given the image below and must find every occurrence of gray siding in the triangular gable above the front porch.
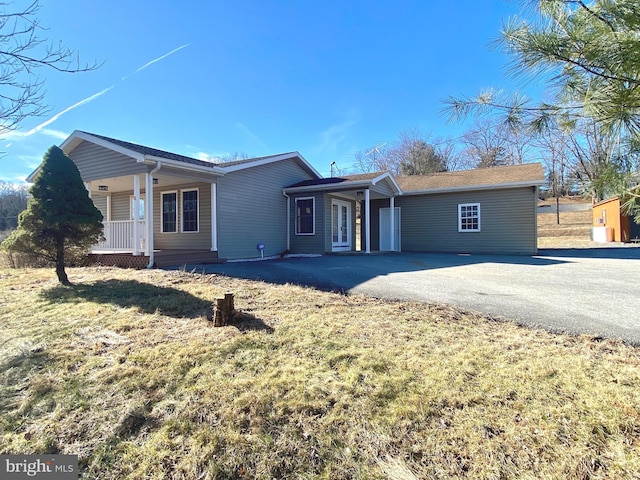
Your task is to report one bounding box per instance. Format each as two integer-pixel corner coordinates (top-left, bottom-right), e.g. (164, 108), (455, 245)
(69, 142), (147, 182)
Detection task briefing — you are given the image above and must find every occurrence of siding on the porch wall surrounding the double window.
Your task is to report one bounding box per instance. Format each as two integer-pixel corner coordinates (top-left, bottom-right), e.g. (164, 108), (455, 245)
(154, 183), (212, 250)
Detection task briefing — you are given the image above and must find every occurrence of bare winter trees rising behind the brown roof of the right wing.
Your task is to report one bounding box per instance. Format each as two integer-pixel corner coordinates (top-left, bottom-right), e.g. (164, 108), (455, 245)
(352, 117), (640, 202)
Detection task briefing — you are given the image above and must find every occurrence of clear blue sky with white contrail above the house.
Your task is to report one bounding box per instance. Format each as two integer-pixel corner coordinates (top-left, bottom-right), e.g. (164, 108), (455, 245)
(0, 0), (539, 181)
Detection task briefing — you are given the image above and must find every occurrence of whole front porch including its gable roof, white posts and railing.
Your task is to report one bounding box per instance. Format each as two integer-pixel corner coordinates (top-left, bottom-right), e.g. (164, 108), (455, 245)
(49, 130), (224, 267)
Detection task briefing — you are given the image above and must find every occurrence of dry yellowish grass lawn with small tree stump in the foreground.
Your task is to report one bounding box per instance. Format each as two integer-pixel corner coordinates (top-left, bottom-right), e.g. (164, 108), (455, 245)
(0, 268), (640, 479)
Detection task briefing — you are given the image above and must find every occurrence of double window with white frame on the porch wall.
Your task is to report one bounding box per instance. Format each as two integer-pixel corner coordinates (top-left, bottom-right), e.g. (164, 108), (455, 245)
(160, 188), (200, 233)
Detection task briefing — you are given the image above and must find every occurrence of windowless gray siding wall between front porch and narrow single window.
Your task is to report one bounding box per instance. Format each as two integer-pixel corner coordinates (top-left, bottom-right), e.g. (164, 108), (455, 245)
(218, 159), (317, 259)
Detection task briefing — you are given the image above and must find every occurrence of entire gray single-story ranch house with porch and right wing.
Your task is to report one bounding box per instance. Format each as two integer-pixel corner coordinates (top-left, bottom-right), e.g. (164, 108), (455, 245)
(30, 131), (545, 267)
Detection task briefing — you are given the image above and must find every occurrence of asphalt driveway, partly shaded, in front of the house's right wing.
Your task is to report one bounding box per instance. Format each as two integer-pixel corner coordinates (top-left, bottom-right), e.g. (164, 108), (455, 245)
(189, 248), (640, 345)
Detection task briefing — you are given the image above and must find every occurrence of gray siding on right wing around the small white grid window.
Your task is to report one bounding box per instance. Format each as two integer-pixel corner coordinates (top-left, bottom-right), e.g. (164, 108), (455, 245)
(390, 187), (537, 254)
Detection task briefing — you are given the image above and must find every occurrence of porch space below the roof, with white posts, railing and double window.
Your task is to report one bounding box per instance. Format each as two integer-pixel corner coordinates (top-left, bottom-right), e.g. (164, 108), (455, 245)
(85, 171), (218, 266)
